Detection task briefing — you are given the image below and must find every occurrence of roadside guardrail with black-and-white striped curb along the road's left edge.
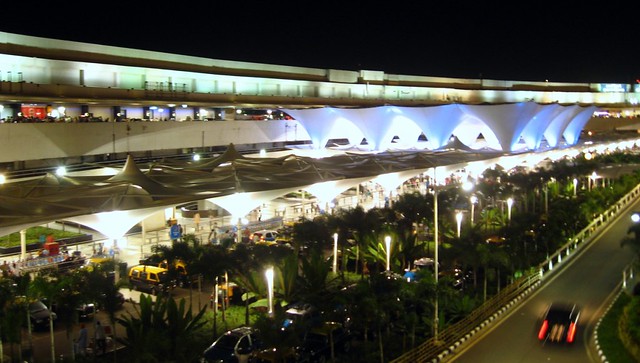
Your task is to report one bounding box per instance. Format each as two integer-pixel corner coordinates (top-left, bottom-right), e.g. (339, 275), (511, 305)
(391, 184), (640, 363)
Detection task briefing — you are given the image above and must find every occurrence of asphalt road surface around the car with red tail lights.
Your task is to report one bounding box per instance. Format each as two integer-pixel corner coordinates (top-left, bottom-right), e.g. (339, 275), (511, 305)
(447, 202), (640, 363)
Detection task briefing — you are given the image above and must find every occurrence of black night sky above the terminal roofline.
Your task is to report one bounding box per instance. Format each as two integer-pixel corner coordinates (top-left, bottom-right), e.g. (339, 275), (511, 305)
(0, 0), (640, 83)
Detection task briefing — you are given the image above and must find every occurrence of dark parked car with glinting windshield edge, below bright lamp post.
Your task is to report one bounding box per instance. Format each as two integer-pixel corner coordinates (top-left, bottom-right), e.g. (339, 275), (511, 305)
(200, 326), (262, 363)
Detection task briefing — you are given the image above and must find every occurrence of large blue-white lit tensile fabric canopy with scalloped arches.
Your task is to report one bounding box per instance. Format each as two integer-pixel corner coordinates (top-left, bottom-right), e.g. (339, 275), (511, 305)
(283, 102), (597, 152)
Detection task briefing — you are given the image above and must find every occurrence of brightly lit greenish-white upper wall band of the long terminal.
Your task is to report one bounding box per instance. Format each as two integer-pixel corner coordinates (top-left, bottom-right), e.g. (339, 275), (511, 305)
(0, 54), (640, 106)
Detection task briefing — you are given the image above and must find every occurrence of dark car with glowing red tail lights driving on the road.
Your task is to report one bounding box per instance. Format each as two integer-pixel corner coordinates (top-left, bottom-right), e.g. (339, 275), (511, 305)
(538, 302), (580, 344)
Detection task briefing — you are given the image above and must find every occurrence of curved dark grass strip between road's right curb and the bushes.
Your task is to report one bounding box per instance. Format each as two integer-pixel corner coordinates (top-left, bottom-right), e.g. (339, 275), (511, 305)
(598, 293), (635, 363)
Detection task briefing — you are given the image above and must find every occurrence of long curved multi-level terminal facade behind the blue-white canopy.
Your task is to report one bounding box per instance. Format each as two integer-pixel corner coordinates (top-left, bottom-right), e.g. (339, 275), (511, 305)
(0, 33), (640, 171)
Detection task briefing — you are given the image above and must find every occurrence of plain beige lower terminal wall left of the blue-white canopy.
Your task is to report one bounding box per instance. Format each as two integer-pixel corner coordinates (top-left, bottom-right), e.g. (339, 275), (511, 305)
(0, 120), (309, 167)
